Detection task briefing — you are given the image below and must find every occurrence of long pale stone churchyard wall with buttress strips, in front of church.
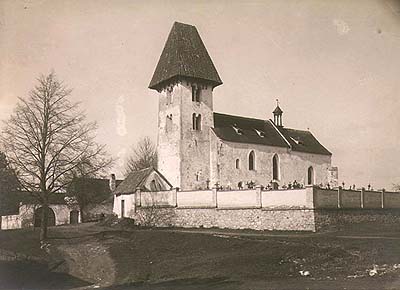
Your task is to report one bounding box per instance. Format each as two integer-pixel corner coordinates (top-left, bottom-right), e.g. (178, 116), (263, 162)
(114, 187), (400, 231)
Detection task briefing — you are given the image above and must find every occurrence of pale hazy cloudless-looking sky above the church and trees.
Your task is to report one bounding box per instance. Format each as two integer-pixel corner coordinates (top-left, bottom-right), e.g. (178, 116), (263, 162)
(0, 0), (400, 189)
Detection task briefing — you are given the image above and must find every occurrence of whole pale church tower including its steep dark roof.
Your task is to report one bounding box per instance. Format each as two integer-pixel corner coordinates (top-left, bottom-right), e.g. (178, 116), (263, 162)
(149, 22), (222, 190)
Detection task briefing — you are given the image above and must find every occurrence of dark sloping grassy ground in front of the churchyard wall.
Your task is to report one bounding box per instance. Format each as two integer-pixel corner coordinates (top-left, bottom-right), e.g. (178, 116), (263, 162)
(0, 224), (400, 290)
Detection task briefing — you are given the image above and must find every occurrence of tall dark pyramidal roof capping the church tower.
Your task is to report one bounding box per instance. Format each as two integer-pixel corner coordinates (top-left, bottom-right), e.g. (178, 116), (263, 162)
(149, 22), (222, 90)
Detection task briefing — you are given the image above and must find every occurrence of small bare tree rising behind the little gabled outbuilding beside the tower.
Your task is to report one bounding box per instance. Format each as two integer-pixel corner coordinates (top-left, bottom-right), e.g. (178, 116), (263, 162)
(125, 136), (157, 175)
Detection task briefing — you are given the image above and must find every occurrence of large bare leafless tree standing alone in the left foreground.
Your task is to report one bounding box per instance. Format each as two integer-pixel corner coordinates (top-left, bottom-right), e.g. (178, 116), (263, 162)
(1, 73), (110, 240)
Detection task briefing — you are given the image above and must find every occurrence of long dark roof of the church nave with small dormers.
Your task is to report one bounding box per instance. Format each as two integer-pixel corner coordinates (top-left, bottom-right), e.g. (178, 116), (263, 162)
(213, 113), (332, 155)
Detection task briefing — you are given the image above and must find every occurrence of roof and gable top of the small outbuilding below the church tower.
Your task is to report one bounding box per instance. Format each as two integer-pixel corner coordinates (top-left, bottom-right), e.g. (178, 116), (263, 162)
(115, 167), (172, 195)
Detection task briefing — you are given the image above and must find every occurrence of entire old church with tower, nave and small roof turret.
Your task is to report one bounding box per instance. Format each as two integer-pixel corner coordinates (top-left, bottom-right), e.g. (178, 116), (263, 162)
(149, 22), (337, 190)
